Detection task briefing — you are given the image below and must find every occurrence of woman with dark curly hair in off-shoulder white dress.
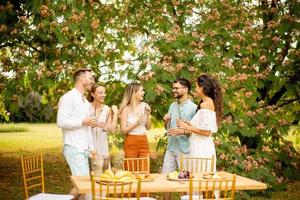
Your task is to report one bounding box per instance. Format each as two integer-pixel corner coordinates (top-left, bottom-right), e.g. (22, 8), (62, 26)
(177, 74), (223, 170)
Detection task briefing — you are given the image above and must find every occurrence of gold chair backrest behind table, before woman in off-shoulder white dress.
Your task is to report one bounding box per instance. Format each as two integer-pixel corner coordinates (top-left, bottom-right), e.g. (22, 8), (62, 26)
(180, 156), (215, 173)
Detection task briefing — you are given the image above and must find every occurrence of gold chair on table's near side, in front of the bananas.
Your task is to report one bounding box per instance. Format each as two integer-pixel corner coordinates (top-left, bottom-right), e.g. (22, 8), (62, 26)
(91, 172), (141, 200)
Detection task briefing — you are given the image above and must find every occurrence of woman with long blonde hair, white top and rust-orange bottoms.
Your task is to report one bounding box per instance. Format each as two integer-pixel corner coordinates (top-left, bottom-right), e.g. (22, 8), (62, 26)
(120, 83), (151, 171)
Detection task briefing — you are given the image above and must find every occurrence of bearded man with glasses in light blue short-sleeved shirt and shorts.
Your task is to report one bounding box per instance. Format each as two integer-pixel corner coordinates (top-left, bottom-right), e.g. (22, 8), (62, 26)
(162, 78), (197, 200)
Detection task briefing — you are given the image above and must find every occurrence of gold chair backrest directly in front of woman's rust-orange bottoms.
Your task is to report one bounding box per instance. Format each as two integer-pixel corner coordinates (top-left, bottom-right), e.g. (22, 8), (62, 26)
(123, 155), (150, 174)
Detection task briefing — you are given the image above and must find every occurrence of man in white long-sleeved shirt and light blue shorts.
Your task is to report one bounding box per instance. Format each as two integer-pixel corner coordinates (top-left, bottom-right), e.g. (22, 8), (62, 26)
(57, 69), (97, 197)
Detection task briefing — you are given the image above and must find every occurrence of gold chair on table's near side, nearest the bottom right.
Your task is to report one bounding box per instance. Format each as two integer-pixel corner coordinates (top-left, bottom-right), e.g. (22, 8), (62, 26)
(181, 174), (236, 200)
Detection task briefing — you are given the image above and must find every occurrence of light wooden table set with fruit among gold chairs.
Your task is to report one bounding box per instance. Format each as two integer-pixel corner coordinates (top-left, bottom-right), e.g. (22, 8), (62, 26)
(71, 172), (267, 194)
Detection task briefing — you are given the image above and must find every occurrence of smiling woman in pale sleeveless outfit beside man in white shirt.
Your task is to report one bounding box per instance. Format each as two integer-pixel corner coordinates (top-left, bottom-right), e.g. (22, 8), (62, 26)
(89, 85), (119, 157)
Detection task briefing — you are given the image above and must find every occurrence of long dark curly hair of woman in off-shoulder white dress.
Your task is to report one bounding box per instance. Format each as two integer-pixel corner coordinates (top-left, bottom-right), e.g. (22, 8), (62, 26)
(197, 74), (223, 126)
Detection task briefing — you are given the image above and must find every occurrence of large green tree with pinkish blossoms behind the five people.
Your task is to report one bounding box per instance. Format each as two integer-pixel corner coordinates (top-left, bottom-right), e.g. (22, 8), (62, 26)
(0, 0), (300, 196)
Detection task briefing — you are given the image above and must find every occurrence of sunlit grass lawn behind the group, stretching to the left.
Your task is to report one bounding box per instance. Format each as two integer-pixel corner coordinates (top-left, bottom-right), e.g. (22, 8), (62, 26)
(0, 124), (300, 200)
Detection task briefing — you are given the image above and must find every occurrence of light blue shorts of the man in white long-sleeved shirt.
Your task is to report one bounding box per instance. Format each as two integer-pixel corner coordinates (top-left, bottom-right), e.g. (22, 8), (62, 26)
(63, 144), (90, 176)
